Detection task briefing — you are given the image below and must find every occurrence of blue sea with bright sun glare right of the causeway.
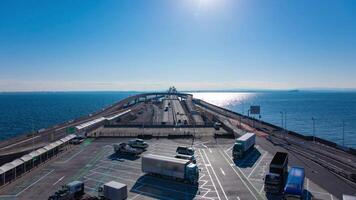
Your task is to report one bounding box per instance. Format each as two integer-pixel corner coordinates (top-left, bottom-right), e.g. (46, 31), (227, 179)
(193, 91), (356, 147)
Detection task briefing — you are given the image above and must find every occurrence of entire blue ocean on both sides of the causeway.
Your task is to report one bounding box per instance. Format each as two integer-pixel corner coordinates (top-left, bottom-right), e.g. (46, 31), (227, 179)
(0, 91), (356, 147)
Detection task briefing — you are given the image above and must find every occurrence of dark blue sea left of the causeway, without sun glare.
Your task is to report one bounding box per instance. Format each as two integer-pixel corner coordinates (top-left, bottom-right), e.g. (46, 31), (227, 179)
(0, 92), (134, 139)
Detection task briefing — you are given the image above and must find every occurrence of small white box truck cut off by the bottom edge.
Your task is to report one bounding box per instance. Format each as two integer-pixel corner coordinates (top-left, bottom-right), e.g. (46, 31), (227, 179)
(98, 181), (127, 200)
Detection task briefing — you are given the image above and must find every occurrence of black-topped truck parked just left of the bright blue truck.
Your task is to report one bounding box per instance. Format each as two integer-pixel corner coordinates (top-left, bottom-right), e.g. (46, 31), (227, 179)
(264, 152), (288, 194)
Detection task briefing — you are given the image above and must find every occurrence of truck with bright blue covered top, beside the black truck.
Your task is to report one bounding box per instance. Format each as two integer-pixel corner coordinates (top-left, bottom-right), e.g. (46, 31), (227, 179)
(284, 167), (305, 200)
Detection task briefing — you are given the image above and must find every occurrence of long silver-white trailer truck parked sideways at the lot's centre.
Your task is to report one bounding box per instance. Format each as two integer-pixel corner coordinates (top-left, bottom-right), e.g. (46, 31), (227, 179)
(142, 154), (199, 184)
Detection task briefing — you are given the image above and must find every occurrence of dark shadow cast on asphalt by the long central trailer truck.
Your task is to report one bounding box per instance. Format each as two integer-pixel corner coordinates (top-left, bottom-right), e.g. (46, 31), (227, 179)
(130, 174), (199, 200)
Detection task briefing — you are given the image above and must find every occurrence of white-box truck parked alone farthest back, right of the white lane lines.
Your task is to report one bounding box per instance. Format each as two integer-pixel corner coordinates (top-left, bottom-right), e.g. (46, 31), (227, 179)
(232, 133), (256, 159)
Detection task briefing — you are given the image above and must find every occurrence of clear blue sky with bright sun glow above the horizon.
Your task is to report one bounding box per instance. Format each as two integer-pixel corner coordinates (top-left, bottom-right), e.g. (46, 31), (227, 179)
(0, 0), (356, 91)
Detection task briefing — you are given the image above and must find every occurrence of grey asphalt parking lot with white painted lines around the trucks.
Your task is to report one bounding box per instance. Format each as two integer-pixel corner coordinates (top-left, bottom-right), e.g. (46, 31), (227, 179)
(0, 137), (336, 200)
